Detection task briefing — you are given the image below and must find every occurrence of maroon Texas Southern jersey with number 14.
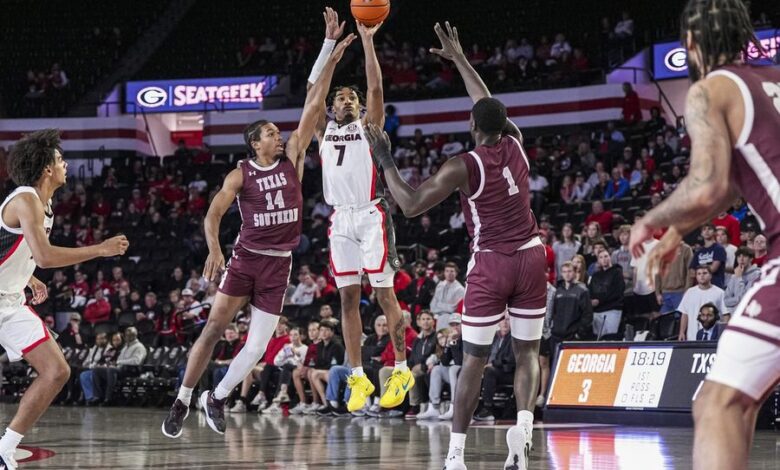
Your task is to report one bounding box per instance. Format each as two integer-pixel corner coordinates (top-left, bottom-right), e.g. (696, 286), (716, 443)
(236, 157), (303, 251)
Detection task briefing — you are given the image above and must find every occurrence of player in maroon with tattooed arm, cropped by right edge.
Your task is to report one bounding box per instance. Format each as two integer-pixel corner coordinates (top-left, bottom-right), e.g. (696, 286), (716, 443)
(630, 0), (780, 470)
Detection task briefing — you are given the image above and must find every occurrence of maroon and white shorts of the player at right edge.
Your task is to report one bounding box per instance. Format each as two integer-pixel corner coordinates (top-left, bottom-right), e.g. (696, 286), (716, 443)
(707, 258), (780, 400)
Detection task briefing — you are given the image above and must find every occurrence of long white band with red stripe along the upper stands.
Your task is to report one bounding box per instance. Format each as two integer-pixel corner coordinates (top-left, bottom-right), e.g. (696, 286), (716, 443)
(0, 84), (659, 155)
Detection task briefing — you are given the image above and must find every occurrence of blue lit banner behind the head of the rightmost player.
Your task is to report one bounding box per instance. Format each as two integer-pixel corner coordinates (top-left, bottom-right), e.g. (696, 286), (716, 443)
(653, 29), (780, 80)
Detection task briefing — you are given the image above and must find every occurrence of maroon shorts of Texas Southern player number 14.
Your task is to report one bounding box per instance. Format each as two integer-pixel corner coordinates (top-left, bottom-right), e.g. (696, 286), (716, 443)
(219, 246), (292, 315)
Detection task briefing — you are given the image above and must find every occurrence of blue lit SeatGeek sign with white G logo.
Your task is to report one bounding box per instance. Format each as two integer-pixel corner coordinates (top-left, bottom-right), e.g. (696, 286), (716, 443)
(125, 75), (279, 113)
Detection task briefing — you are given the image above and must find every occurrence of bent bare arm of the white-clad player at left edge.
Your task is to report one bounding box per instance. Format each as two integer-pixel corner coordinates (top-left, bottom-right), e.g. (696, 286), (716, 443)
(12, 194), (130, 268)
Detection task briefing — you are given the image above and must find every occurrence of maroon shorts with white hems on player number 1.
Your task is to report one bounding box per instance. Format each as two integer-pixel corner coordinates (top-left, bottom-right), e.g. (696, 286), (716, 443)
(462, 238), (547, 345)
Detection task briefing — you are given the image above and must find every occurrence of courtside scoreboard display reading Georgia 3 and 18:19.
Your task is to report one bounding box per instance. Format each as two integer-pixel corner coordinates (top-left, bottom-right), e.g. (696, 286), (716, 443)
(547, 342), (716, 411)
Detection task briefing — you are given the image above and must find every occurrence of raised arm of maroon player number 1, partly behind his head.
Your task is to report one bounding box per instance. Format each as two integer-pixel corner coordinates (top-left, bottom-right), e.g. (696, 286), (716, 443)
(431, 21), (523, 143)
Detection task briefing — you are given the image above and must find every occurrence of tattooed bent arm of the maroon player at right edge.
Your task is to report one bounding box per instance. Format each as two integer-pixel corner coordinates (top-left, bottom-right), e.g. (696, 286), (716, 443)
(629, 79), (742, 257)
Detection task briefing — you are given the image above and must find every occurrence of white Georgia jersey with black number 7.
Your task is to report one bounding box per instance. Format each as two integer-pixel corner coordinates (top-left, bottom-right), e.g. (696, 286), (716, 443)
(320, 120), (384, 207)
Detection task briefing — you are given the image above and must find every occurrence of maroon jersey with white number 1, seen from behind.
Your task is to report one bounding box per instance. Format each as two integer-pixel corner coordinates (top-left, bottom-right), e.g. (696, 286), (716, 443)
(458, 136), (539, 254)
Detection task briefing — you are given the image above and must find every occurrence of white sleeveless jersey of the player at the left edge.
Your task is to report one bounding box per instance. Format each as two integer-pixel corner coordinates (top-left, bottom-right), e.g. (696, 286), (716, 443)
(0, 186), (54, 294)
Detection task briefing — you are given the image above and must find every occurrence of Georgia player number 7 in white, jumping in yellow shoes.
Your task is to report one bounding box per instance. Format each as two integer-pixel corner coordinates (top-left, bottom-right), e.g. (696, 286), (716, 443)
(317, 23), (414, 412)
